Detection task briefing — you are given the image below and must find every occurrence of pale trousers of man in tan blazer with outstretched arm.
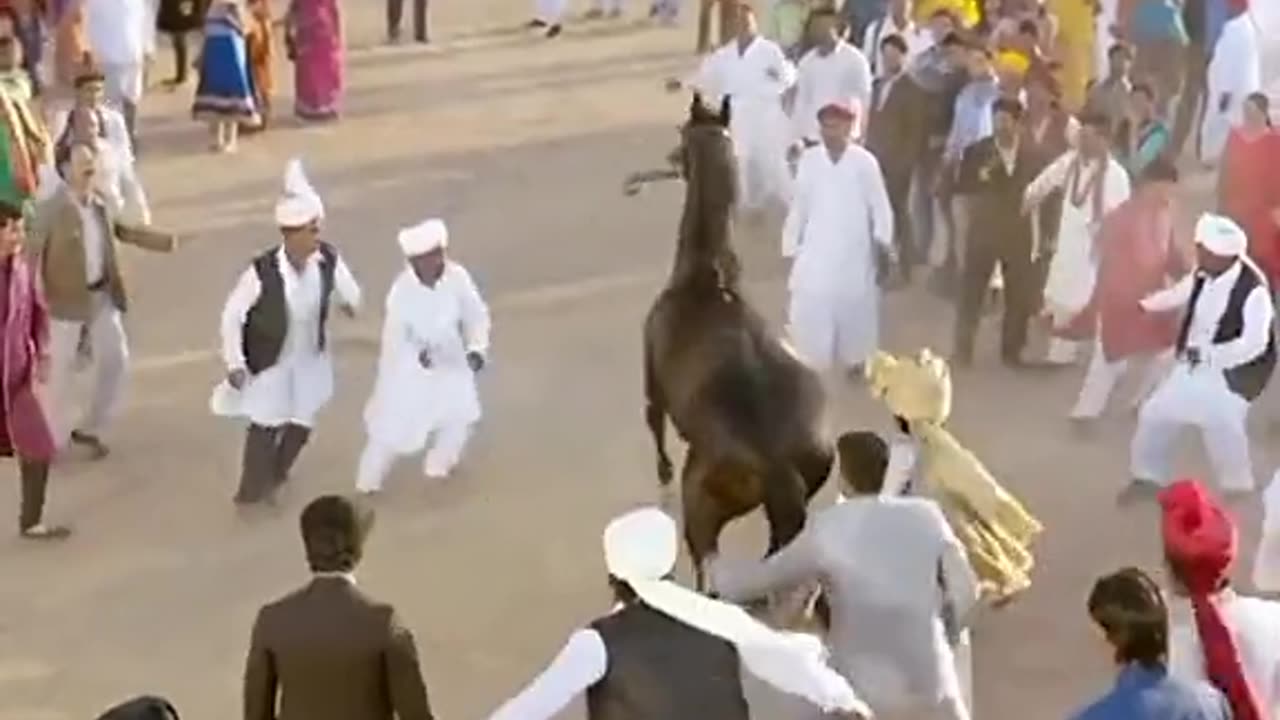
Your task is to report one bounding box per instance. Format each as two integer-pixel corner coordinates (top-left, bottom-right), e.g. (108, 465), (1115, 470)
(49, 292), (129, 448)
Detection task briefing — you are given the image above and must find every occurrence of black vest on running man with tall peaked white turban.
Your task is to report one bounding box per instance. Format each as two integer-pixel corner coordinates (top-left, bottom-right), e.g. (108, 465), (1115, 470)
(241, 242), (338, 375)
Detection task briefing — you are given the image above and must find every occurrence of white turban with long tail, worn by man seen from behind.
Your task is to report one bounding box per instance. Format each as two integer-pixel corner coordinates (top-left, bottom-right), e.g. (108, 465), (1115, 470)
(604, 507), (870, 716)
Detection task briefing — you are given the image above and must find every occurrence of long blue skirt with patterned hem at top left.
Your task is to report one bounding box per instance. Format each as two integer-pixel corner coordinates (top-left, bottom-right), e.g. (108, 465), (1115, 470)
(191, 26), (259, 124)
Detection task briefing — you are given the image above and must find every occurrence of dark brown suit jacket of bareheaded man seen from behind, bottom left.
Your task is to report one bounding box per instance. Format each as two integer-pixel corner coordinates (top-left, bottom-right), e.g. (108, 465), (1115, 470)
(244, 577), (433, 720)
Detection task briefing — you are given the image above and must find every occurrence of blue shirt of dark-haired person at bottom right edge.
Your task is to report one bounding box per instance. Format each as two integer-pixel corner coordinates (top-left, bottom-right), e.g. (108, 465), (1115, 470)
(1073, 665), (1231, 720)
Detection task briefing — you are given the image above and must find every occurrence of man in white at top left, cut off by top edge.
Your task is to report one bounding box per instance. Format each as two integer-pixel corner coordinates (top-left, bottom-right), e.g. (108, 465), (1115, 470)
(84, 0), (156, 140)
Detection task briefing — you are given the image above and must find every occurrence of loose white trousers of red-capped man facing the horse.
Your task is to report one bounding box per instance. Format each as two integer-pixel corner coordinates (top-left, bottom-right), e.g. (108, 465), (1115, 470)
(787, 290), (879, 372)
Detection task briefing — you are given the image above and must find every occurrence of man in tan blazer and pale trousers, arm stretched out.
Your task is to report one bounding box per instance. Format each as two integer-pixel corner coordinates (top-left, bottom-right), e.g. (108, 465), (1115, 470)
(29, 143), (178, 459)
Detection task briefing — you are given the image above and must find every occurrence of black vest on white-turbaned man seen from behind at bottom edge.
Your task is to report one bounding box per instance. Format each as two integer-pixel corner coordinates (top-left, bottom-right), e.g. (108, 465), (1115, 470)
(586, 602), (750, 720)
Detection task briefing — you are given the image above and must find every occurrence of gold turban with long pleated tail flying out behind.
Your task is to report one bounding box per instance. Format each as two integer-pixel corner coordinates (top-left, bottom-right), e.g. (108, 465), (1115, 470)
(867, 350), (1043, 598)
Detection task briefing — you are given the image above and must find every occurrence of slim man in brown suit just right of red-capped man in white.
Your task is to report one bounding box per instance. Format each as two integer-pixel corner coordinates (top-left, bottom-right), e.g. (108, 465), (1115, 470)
(867, 35), (927, 279)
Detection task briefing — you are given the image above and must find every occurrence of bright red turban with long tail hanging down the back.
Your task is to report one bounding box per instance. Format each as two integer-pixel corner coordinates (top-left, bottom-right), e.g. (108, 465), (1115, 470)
(1160, 480), (1266, 720)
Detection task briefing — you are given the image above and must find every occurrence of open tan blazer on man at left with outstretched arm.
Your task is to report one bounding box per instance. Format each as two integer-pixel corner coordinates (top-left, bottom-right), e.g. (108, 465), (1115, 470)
(27, 186), (178, 323)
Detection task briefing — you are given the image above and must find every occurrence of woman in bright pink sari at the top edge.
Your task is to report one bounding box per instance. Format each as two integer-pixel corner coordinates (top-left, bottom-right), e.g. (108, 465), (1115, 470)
(285, 0), (344, 120)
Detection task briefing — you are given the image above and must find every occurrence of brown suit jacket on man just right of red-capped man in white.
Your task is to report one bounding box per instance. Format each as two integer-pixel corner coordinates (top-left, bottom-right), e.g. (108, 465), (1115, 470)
(867, 72), (928, 178)
